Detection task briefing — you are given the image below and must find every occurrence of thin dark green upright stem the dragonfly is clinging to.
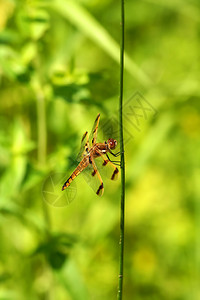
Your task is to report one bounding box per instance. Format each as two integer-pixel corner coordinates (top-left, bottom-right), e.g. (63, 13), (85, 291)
(117, 0), (125, 300)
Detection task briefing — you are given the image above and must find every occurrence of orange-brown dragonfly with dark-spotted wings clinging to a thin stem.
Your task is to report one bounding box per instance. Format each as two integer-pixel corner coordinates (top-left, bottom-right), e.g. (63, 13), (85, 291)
(62, 114), (120, 196)
